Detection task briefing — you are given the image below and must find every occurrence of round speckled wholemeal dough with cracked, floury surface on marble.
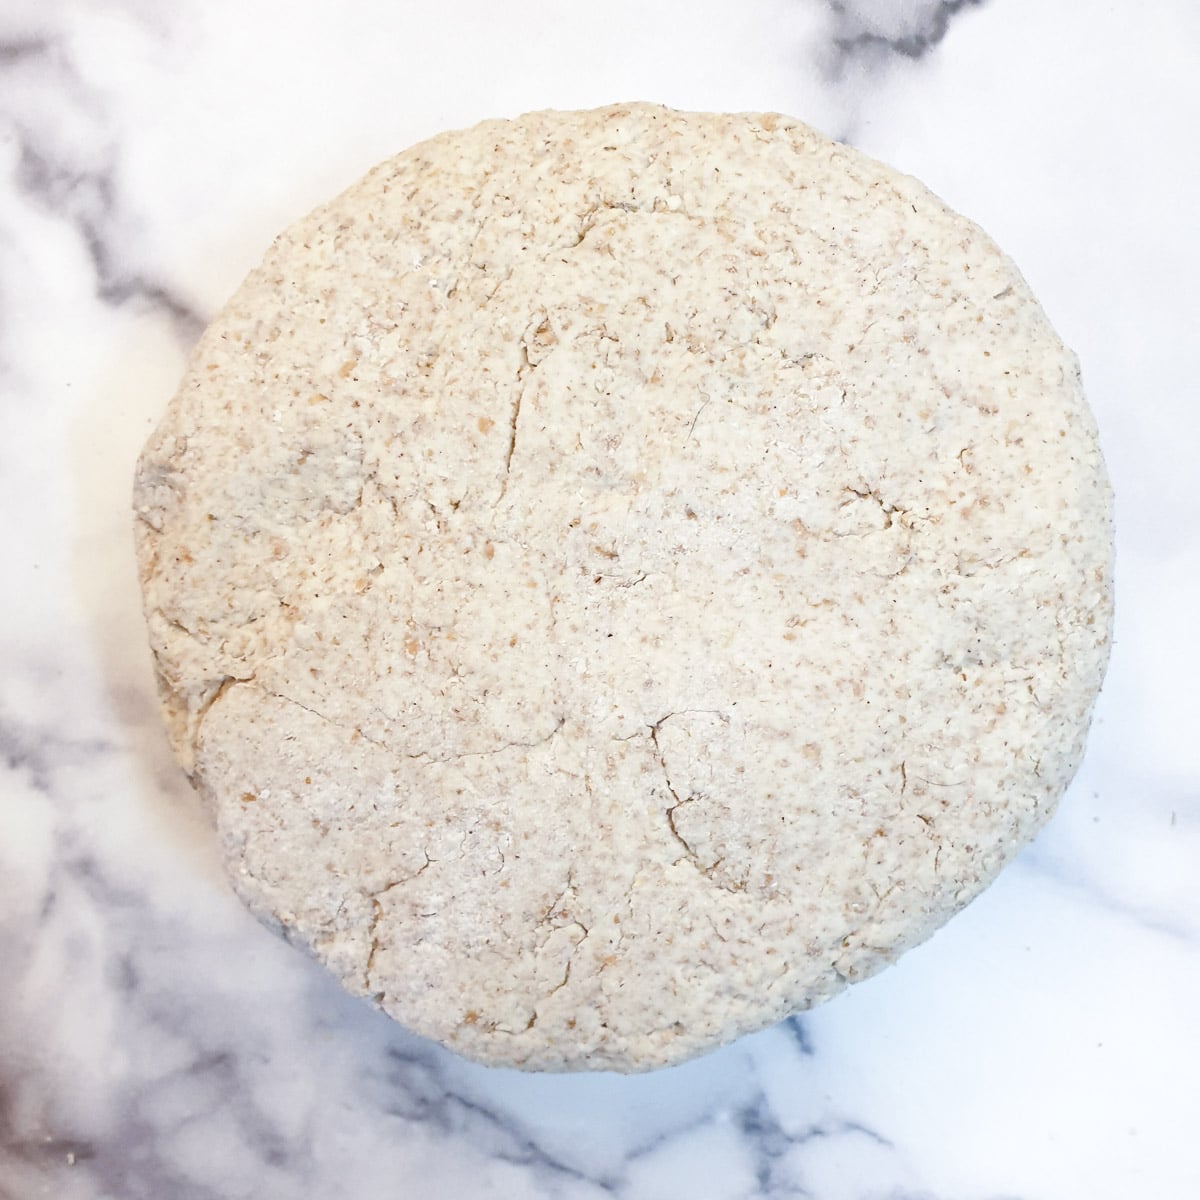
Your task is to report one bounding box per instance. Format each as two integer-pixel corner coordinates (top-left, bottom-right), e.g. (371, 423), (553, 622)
(136, 104), (1111, 1070)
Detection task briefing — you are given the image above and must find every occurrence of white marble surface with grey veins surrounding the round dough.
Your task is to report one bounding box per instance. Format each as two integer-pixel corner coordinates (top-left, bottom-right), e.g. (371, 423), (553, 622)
(0, 0), (1200, 1200)
